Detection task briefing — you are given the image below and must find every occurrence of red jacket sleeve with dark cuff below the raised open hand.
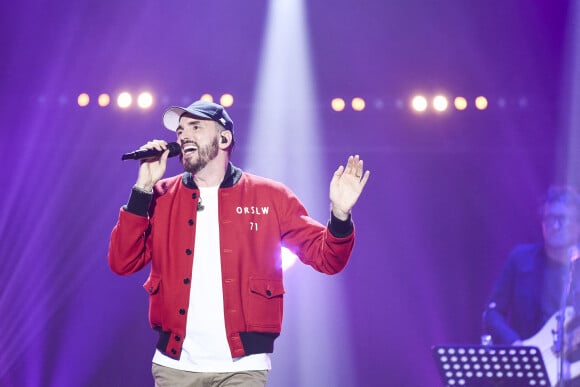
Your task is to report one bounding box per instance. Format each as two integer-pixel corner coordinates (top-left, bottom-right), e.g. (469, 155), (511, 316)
(280, 192), (355, 274)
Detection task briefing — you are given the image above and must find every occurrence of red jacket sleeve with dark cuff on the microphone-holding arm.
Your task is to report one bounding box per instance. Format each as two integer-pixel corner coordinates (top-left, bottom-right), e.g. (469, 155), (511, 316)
(108, 189), (153, 275)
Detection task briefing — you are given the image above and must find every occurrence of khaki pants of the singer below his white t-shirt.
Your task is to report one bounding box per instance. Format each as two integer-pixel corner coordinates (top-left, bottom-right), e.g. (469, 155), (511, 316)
(151, 363), (268, 387)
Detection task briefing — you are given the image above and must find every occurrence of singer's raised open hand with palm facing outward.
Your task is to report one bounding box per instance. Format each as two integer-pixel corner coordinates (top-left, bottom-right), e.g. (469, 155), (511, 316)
(330, 155), (371, 220)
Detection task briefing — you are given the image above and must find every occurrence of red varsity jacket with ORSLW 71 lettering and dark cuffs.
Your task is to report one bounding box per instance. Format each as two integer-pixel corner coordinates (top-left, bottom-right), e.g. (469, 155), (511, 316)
(108, 164), (354, 359)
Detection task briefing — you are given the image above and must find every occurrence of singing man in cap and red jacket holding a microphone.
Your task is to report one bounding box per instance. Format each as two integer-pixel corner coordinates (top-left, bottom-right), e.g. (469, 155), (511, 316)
(108, 101), (370, 387)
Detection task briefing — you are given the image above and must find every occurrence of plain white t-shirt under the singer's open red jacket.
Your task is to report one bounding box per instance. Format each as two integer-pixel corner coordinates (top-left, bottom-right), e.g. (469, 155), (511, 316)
(153, 187), (271, 372)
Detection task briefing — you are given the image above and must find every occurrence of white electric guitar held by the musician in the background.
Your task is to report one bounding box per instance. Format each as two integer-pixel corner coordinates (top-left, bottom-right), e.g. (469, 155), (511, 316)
(522, 306), (580, 386)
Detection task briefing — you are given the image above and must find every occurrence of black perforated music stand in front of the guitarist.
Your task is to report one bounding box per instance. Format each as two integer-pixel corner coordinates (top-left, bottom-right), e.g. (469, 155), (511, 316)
(432, 345), (550, 387)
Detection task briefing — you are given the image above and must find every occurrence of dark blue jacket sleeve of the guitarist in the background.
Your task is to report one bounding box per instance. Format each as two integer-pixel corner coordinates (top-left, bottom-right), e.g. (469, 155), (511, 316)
(483, 253), (522, 344)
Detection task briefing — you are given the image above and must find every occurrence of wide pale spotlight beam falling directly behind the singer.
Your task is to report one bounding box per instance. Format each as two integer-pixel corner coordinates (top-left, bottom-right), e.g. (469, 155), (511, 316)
(246, 0), (355, 386)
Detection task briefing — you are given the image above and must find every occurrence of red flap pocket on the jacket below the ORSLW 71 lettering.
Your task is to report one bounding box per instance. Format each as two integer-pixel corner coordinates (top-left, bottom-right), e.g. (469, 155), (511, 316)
(246, 278), (284, 332)
